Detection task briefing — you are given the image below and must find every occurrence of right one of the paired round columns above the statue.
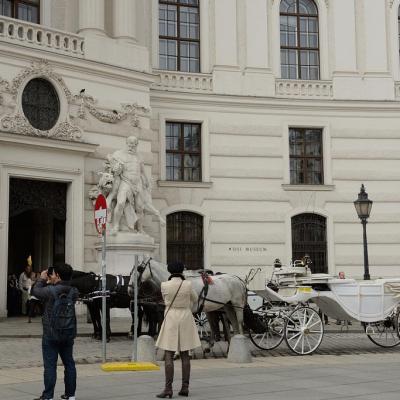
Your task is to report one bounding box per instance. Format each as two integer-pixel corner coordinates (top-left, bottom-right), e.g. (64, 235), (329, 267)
(113, 0), (136, 42)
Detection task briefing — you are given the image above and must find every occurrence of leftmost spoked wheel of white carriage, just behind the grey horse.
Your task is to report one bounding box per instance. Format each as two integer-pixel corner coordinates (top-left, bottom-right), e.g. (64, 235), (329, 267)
(249, 306), (285, 350)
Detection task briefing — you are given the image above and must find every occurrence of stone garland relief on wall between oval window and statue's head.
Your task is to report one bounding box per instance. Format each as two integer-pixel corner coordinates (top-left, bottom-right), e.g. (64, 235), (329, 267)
(74, 93), (150, 127)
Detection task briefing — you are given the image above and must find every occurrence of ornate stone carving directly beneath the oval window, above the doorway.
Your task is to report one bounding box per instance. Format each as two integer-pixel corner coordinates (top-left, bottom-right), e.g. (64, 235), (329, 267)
(0, 113), (82, 141)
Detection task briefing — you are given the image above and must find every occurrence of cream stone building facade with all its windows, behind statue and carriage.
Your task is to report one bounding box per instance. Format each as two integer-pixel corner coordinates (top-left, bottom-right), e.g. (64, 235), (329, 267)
(0, 0), (400, 316)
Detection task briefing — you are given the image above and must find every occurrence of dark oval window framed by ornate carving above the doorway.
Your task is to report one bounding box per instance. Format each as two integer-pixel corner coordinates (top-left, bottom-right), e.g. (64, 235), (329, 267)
(22, 78), (60, 131)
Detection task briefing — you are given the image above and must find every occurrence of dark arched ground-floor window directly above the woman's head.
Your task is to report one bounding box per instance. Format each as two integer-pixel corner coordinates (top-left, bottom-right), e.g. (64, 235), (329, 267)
(167, 211), (204, 269)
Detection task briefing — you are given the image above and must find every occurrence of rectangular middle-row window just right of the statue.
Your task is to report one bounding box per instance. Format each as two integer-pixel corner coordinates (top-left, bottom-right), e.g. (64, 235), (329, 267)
(165, 122), (201, 182)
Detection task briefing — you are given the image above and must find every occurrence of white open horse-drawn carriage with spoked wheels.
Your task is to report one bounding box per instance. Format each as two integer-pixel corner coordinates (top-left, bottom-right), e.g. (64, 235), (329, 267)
(249, 265), (400, 355)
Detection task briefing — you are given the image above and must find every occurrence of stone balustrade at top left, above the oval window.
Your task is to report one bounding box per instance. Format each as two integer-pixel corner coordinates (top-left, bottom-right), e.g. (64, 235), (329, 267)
(0, 16), (85, 57)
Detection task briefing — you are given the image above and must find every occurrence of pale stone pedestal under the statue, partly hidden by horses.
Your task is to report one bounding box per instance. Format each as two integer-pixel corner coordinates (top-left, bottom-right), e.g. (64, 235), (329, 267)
(96, 232), (156, 318)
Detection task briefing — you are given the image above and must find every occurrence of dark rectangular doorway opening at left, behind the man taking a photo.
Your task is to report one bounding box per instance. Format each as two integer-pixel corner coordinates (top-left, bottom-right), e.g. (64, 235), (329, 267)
(8, 178), (67, 277)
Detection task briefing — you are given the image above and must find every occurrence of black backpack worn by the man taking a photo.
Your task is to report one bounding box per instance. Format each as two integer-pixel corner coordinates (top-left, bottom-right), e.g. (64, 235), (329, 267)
(49, 286), (76, 342)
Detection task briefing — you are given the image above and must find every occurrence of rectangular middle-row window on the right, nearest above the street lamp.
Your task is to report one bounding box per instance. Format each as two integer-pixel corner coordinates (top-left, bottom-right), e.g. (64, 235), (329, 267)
(289, 128), (324, 185)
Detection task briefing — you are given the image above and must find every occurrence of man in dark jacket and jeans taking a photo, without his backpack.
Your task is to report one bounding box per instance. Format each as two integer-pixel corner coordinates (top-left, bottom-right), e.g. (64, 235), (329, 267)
(32, 264), (78, 400)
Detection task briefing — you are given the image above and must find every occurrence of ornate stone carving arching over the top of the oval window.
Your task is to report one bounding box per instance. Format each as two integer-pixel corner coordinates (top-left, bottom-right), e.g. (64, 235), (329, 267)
(10, 60), (72, 103)
